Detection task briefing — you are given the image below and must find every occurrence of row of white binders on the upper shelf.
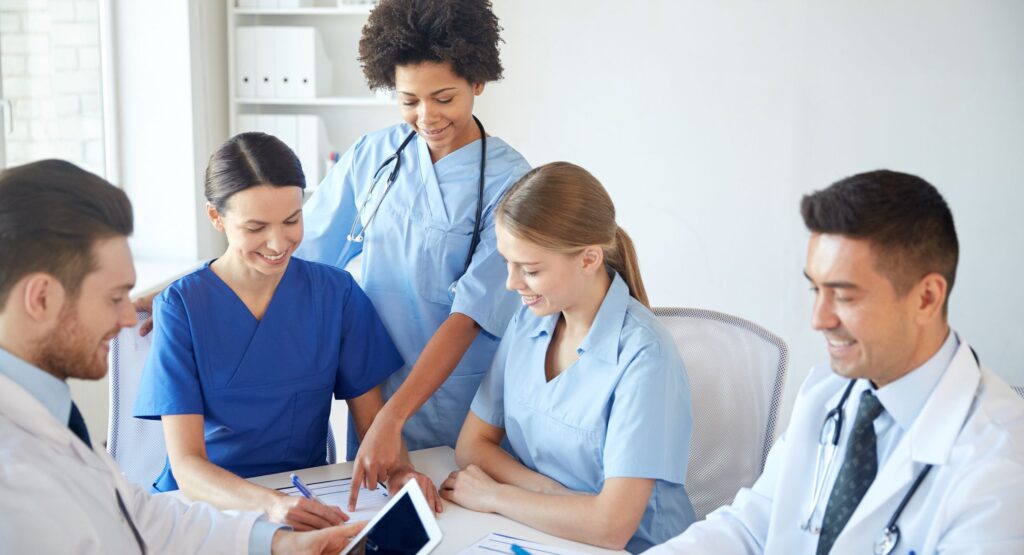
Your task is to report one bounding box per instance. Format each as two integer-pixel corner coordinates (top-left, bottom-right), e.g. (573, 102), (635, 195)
(234, 26), (332, 98)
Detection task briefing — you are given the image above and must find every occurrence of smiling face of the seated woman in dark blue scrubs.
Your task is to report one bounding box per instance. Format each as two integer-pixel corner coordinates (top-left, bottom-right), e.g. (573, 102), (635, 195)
(207, 185), (302, 275)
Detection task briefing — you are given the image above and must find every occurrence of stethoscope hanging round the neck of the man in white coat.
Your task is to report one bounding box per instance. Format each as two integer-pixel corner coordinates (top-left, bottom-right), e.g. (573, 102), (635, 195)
(800, 347), (981, 555)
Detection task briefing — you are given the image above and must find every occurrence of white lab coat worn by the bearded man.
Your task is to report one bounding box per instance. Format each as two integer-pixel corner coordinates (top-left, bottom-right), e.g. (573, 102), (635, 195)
(0, 375), (259, 554)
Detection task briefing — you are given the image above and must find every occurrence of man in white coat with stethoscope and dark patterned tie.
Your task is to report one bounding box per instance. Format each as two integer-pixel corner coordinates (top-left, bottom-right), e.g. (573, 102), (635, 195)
(647, 171), (1024, 555)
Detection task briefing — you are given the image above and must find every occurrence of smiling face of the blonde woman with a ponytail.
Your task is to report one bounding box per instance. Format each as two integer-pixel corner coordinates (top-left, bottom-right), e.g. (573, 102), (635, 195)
(496, 222), (604, 316)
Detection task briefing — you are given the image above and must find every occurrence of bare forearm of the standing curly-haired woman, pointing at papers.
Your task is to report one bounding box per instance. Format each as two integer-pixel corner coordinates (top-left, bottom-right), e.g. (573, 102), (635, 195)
(379, 312), (480, 421)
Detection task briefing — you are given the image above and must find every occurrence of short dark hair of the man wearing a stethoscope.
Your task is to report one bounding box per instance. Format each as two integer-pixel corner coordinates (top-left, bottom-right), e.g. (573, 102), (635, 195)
(800, 170), (959, 301)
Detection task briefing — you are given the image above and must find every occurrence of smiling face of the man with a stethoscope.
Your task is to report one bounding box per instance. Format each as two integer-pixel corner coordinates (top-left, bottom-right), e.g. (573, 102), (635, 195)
(805, 233), (945, 387)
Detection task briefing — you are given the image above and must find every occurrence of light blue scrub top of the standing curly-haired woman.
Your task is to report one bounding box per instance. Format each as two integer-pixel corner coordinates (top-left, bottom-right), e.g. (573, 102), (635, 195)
(297, 124), (529, 459)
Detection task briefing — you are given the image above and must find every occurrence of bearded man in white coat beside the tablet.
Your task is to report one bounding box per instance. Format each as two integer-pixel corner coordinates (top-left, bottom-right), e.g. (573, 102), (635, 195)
(0, 160), (360, 554)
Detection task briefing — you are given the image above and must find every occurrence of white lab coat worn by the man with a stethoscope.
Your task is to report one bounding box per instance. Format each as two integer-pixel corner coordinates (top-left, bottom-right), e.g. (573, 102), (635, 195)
(646, 342), (1024, 555)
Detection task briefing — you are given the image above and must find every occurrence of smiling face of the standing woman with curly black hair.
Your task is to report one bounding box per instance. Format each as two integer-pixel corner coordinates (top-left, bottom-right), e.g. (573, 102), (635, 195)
(394, 61), (483, 162)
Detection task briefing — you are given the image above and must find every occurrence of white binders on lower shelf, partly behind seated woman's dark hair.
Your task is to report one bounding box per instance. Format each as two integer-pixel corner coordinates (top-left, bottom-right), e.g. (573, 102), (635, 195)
(238, 114), (331, 190)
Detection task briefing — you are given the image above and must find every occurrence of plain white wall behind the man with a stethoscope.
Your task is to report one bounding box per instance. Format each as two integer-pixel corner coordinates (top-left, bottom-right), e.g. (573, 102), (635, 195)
(477, 0), (1024, 425)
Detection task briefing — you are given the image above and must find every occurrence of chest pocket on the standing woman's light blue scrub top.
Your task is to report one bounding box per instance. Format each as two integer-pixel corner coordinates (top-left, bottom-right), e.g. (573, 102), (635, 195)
(416, 225), (473, 306)
